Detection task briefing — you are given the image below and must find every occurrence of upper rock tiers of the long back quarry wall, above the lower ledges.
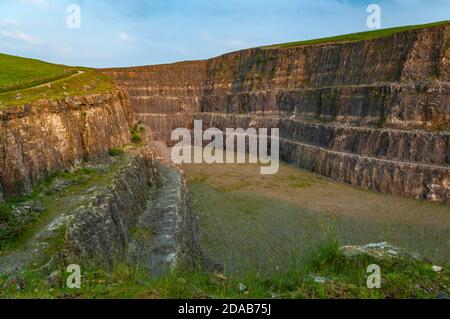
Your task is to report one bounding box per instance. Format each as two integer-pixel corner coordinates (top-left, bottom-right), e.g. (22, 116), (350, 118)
(104, 25), (450, 129)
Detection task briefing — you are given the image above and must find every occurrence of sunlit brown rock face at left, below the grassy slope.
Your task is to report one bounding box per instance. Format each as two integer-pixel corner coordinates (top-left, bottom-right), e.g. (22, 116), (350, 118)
(0, 90), (133, 197)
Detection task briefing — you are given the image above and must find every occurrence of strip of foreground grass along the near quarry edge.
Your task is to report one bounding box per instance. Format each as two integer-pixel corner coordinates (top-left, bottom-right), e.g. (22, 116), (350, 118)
(0, 240), (450, 299)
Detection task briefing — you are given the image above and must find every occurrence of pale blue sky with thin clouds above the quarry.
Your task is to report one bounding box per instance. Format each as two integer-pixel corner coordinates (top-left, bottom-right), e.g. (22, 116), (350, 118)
(0, 0), (450, 67)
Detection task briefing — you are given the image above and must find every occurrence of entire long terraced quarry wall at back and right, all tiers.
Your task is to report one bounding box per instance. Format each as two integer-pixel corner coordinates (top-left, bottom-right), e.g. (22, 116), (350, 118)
(103, 24), (450, 203)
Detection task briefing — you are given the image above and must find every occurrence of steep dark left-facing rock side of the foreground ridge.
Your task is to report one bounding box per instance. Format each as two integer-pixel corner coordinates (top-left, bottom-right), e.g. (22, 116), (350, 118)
(66, 151), (159, 264)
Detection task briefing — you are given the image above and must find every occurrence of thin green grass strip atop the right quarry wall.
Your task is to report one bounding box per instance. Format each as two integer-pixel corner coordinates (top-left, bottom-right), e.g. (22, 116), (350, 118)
(262, 20), (449, 49)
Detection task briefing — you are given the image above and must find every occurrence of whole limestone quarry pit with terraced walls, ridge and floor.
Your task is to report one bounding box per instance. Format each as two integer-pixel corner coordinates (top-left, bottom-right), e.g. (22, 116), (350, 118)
(0, 23), (450, 300)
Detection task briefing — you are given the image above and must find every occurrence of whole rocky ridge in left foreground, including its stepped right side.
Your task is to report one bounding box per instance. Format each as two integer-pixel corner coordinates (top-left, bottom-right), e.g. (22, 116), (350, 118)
(66, 149), (200, 276)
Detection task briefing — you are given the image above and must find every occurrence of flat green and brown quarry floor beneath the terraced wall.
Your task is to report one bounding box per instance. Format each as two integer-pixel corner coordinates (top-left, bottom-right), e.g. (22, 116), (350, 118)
(183, 164), (450, 273)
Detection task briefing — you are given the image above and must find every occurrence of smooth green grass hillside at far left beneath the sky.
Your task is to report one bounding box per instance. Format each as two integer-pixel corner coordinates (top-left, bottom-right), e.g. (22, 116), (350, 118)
(0, 53), (78, 93)
